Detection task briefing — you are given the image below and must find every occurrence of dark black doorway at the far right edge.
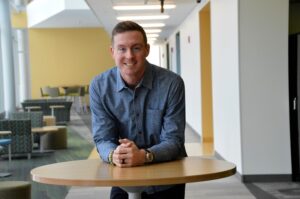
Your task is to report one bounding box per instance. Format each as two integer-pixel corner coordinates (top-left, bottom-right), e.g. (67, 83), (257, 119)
(289, 0), (300, 181)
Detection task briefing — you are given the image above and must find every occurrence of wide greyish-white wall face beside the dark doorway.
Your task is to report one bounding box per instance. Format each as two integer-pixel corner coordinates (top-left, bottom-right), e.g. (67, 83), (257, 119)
(239, 0), (291, 174)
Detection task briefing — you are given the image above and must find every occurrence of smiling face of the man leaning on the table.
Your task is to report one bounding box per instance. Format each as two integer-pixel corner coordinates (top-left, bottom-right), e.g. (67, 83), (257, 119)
(111, 31), (149, 78)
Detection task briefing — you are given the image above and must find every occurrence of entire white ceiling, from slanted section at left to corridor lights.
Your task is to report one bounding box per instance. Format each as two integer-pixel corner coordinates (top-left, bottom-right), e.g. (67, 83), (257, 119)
(27, 0), (197, 43)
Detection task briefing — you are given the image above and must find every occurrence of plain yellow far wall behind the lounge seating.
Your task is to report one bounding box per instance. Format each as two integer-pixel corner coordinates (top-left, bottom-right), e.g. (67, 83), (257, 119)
(29, 28), (114, 98)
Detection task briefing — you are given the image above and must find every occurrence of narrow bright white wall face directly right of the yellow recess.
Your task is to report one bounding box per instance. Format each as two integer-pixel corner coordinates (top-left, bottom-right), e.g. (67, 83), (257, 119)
(211, 0), (243, 173)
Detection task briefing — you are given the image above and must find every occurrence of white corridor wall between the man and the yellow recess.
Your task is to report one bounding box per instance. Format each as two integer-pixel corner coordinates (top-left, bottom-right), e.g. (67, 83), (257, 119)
(164, 1), (207, 138)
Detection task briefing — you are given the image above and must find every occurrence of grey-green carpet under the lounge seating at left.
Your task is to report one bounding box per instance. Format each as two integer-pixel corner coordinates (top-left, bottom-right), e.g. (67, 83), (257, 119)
(0, 127), (93, 199)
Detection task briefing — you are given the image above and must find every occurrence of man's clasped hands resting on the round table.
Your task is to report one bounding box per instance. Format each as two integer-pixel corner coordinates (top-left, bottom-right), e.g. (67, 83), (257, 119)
(113, 139), (145, 167)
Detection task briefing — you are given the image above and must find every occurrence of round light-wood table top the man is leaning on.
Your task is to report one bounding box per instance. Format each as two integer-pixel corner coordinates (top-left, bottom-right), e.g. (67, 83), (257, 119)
(31, 157), (236, 187)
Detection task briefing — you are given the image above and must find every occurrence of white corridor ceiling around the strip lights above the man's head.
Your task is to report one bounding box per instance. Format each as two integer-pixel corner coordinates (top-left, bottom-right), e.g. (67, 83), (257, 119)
(85, 0), (197, 42)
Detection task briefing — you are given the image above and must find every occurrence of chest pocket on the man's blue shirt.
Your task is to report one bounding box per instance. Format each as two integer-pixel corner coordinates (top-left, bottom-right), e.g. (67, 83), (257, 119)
(146, 109), (163, 137)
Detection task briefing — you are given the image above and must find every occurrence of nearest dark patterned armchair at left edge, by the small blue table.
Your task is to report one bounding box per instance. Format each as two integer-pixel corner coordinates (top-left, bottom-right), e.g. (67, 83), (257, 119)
(0, 120), (32, 159)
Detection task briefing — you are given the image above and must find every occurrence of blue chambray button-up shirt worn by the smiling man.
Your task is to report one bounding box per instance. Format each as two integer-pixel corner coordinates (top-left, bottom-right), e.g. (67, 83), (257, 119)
(90, 62), (187, 193)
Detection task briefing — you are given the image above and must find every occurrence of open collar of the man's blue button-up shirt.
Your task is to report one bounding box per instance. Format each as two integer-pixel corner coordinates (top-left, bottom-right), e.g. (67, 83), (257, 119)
(117, 61), (153, 92)
